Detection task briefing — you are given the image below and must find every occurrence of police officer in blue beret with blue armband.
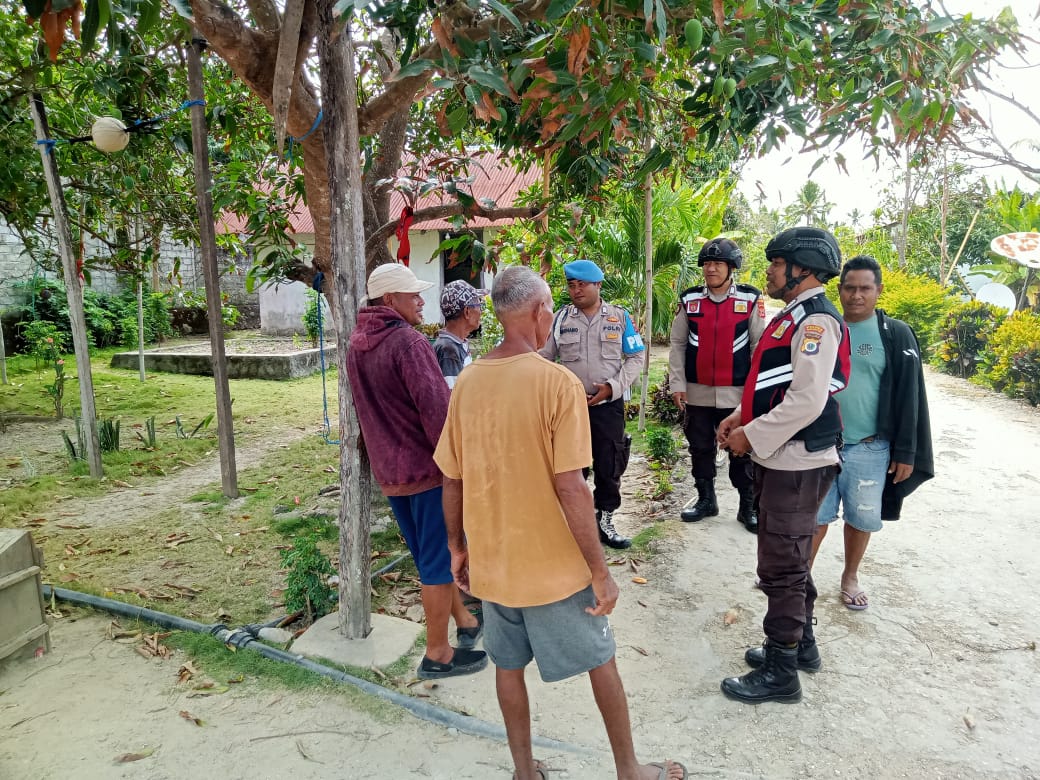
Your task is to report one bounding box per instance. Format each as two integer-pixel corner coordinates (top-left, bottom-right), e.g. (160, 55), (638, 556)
(539, 260), (646, 549)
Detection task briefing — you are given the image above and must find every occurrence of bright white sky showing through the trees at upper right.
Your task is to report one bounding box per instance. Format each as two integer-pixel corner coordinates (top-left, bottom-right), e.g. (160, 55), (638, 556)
(739, 0), (1040, 224)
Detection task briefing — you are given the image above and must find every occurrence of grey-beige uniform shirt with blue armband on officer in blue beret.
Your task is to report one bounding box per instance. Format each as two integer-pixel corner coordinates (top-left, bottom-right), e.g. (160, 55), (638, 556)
(539, 304), (646, 404)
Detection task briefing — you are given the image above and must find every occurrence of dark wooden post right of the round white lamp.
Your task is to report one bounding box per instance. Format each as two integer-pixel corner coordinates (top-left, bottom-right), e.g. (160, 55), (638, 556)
(187, 35), (238, 498)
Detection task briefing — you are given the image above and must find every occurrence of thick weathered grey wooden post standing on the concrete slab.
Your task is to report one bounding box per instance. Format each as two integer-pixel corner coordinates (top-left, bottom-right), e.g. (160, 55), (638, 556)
(317, 0), (372, 640)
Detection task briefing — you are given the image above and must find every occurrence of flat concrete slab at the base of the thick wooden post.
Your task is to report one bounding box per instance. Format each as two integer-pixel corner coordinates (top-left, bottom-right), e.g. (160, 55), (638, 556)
(291, 613), (423, 669)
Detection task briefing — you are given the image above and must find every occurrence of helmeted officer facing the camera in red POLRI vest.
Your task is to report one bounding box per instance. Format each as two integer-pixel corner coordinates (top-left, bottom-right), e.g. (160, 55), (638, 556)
(668, 236), (765, 534)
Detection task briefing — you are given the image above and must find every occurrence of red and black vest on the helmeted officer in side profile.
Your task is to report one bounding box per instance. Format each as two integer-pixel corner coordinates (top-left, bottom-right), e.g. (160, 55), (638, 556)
(740, 290), (851, 452)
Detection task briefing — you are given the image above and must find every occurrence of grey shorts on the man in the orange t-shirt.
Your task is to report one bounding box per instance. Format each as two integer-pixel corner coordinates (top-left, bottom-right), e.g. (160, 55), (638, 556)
(484, 586), (616, 682)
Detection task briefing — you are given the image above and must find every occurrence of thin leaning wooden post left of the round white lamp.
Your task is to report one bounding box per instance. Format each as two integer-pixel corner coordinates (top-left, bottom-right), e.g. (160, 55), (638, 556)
(29, 93), (104, 479)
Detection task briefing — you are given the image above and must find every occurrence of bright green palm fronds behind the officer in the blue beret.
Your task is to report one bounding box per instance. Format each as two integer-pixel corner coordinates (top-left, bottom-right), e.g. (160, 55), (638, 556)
(584, 179), (731, 336)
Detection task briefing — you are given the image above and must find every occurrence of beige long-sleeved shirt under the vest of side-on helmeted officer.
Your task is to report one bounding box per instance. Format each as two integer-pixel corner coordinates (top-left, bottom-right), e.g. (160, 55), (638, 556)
(744, 287), (841, 471)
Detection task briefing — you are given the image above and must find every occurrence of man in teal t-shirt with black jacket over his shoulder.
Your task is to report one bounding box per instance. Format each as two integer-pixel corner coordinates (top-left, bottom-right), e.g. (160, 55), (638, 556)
(812, 255), (934, 610)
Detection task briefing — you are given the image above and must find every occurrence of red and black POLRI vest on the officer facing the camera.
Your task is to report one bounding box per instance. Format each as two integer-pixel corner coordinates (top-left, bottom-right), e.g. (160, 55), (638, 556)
(679, 284), (761, 387)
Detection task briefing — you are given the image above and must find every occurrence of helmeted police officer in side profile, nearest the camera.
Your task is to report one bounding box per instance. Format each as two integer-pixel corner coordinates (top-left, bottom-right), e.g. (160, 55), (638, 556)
(718, 228), (850, 704)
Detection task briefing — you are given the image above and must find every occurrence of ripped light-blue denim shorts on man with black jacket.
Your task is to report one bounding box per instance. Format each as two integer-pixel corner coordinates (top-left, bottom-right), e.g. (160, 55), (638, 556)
(816, 439), (889, 534)
